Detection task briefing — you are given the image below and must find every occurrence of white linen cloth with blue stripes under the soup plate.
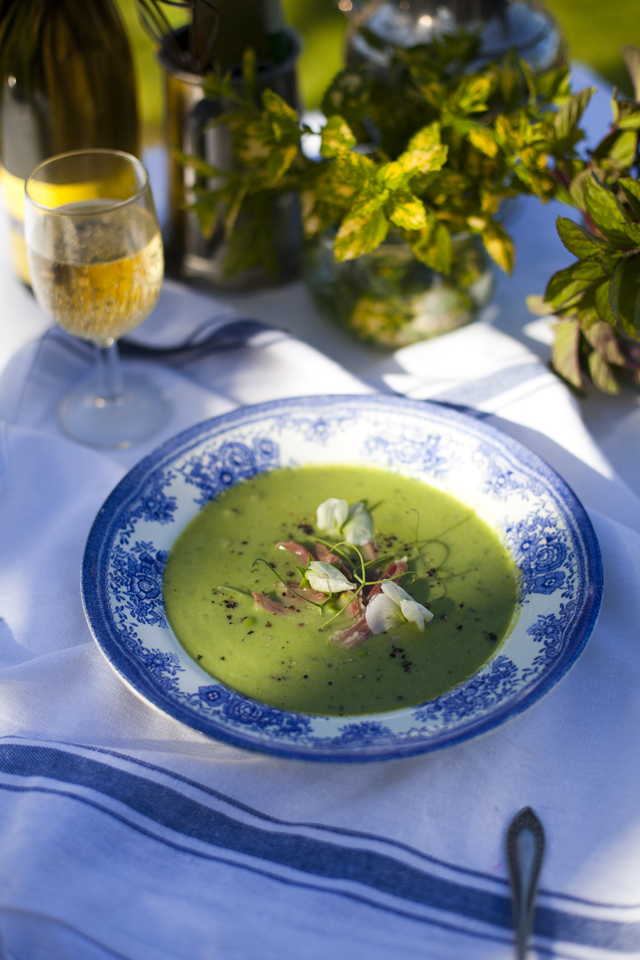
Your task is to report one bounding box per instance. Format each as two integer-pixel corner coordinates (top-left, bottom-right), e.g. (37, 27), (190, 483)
(0, 284), (640, 960)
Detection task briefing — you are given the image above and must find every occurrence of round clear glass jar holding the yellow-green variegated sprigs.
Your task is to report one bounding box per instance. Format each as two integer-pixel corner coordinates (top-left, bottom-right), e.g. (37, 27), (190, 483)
(303, 228), (493, 350)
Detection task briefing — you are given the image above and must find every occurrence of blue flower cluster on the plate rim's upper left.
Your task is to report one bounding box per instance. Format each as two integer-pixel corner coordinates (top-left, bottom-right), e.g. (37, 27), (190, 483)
(178, 437), (280, 506)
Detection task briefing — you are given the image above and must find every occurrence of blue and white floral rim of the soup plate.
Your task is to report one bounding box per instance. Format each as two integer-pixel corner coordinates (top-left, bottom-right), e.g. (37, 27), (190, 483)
(82, 396), (602, 760)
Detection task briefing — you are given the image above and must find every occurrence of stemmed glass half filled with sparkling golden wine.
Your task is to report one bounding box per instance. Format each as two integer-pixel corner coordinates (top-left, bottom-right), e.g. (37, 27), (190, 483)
(24, 150), (171, 448)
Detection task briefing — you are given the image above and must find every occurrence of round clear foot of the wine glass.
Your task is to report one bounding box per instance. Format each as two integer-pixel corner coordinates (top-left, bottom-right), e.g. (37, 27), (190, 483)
(58, 373), (172, 450)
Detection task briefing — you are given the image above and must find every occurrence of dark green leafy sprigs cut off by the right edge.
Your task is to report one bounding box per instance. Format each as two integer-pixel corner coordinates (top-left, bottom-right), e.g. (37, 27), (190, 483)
(530, 47), (640, 393)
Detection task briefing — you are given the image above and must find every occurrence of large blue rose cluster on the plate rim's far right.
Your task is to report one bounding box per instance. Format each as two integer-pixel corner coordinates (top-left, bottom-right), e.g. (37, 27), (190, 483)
(506, 512), (574, 597)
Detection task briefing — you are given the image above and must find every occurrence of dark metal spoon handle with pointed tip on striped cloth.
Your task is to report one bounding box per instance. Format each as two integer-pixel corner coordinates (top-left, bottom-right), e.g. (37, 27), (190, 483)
(506, 807), (545, 960)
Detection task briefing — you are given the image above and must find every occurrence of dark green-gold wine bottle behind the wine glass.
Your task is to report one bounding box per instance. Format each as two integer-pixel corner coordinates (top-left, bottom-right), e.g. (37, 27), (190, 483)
(0, 0), (139, 283)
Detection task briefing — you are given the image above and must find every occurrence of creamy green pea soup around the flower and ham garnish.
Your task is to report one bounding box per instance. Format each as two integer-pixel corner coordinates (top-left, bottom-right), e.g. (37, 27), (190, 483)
(163, 466), (517, 716)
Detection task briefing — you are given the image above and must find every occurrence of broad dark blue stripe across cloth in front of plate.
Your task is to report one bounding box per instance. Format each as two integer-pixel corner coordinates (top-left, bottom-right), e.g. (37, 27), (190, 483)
(0, 744), (640, 953)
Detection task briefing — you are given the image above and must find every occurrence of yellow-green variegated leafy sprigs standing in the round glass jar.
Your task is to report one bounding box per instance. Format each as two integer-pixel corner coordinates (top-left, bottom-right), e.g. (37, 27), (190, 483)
(182, 32), (592, 274)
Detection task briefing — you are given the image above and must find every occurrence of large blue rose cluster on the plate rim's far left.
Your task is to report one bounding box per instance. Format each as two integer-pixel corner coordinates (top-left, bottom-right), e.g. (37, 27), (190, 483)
(109, 541), (168, 627)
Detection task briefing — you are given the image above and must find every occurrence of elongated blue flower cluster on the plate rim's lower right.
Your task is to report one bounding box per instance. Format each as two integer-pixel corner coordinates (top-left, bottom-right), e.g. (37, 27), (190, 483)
(414, 654), (518, 724)
